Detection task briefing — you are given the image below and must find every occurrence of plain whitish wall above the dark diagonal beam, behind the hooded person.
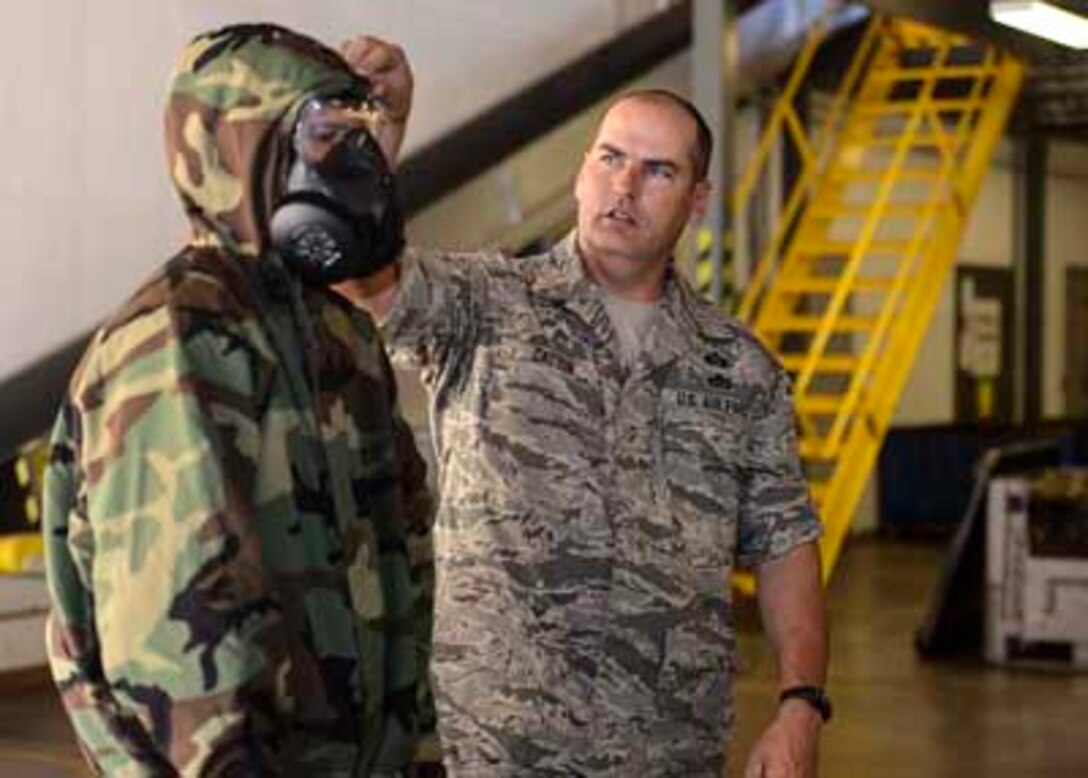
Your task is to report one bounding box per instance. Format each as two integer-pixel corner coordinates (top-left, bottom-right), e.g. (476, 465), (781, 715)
(0, 0), (667, 380)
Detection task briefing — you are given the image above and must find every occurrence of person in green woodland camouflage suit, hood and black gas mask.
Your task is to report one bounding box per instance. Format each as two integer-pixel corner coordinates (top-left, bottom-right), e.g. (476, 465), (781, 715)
(44, 25), (433, 776)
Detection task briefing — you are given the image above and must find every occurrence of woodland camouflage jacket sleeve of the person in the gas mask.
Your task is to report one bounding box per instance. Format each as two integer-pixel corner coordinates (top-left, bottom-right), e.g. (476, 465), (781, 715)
(44, 310), (286, 776)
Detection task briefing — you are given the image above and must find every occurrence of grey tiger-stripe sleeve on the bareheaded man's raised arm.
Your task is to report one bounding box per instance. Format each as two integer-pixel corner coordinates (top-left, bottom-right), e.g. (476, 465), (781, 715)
(382, 249), (486, 368)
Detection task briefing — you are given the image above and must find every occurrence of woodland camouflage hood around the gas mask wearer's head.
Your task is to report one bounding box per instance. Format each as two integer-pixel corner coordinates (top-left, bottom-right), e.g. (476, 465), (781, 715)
(166, 24), (369, 257)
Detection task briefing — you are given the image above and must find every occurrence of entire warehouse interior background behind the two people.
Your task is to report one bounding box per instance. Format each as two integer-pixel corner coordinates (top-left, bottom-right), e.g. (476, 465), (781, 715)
(0, 0), (1088, 777)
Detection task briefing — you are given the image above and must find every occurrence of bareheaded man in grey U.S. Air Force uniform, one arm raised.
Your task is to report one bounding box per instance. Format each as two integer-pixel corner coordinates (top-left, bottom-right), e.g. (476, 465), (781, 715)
(345, 38), (827, 778)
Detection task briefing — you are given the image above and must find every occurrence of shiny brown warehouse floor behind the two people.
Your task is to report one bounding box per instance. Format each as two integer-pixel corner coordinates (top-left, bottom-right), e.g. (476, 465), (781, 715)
(0, 541), (1088, 778)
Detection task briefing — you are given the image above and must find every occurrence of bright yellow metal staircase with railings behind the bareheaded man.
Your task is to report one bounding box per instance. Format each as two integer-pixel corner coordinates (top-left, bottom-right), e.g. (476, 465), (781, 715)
(732, 16), (1023, 591)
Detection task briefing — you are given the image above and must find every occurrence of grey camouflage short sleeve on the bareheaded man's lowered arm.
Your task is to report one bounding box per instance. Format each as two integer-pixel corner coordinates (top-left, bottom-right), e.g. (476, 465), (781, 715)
(737, 369), (820, 569)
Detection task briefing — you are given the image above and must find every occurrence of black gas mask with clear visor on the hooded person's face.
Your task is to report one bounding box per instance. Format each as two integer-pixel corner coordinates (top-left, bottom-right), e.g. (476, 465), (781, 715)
(269, 98), (404, 286)
